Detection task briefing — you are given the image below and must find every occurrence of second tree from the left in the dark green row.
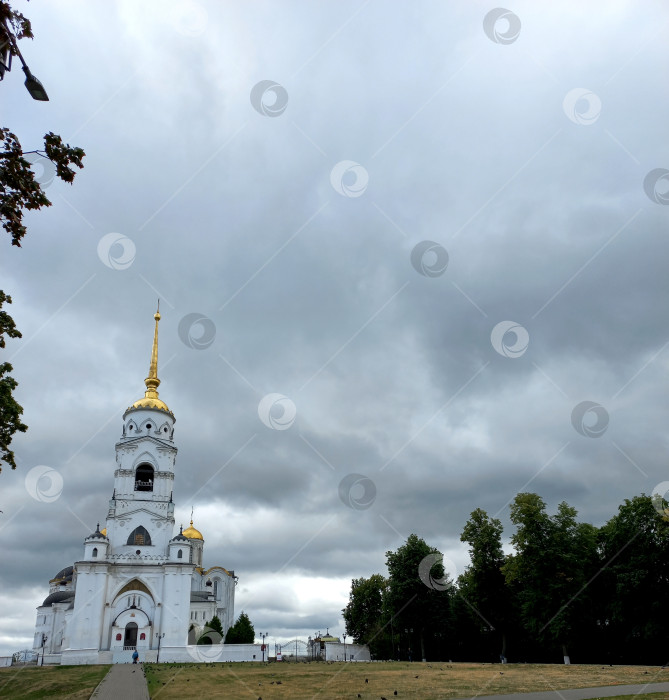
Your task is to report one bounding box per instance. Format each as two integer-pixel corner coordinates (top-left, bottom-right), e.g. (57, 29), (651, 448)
(386, 534), (452, 659)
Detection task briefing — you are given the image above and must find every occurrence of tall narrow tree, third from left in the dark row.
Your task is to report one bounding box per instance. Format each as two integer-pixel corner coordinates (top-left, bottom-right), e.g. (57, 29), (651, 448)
(458, 508), (514, 658)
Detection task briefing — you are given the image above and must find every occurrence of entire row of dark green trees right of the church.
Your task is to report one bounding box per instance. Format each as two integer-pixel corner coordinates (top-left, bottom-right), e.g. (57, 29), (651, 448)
(343, 493), (669, 664)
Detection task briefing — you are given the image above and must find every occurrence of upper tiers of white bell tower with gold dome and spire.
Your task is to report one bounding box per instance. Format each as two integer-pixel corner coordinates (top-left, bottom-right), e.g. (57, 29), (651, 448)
(106, 310), (177, 559)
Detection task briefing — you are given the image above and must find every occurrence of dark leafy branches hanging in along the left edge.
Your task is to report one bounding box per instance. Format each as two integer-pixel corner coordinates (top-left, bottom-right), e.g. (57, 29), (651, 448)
(0, 0), (85, 469)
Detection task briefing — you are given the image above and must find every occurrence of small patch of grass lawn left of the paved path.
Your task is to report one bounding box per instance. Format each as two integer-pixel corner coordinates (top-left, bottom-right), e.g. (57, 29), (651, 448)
(0, 666), (109, 700)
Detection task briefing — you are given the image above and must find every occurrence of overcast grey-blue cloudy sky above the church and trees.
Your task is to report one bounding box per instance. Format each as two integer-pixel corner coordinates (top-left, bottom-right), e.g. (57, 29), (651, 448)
(0, 0), (669, 653)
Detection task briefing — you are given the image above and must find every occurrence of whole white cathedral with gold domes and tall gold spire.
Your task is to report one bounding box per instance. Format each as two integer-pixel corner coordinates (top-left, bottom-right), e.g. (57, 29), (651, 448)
(34, 312), (240, 664)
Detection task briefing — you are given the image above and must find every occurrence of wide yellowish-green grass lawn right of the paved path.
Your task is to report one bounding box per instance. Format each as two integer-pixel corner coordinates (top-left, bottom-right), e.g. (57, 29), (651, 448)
(144, 662), (669, 700)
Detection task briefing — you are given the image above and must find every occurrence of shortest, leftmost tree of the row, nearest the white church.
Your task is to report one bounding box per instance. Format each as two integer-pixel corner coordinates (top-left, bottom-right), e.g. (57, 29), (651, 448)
(342, 574), (388, 658)
